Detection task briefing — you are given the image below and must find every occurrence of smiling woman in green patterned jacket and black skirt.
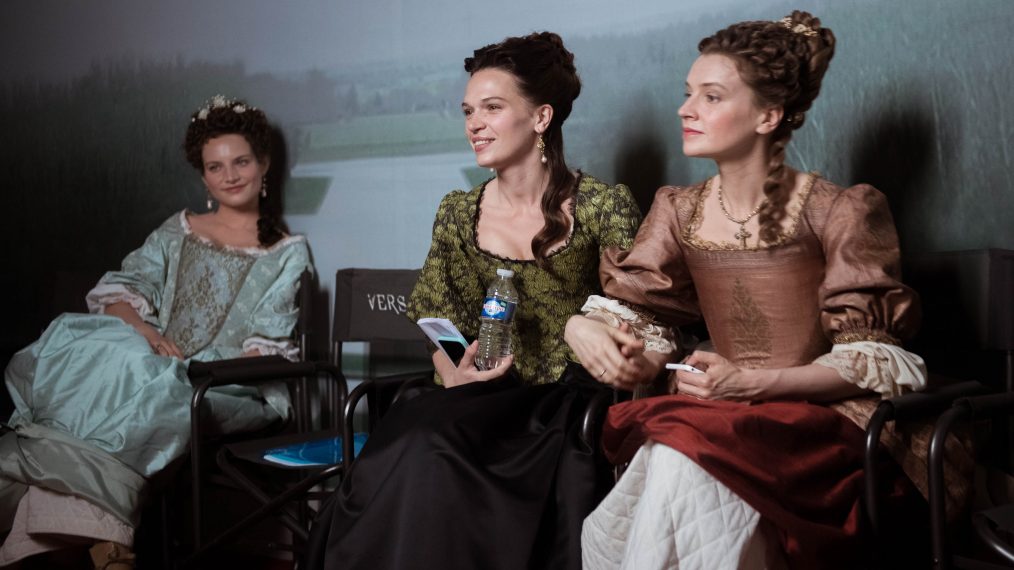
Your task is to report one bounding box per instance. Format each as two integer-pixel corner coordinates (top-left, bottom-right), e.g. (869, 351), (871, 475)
(306, 32), (641, 569)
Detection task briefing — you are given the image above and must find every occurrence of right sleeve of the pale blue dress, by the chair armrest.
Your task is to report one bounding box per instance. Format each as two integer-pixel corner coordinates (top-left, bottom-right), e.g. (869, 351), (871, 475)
(242, 237), (313, 359)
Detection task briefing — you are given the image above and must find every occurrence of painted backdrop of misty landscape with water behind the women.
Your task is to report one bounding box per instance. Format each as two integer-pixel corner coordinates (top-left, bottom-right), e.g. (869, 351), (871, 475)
(0, 0), (1014, 359)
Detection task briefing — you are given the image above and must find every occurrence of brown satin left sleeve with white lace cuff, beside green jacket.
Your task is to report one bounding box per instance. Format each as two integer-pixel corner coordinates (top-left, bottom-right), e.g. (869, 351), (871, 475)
(582, 187), (701, 353)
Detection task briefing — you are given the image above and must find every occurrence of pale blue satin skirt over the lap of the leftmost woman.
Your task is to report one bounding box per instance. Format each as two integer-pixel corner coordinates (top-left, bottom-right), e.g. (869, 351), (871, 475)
(7, 313), (278, 477)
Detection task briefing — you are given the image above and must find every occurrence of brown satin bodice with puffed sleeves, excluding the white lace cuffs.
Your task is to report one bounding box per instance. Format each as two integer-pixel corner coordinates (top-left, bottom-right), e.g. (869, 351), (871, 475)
(599, 177), (919, 368)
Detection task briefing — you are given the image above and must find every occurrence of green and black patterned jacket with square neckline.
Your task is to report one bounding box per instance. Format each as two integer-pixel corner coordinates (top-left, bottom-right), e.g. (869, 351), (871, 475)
(408, 174), (641, 383)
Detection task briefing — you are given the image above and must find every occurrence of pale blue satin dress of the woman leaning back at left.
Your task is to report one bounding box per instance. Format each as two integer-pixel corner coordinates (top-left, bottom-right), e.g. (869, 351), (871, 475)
(0, 212), (310, 532)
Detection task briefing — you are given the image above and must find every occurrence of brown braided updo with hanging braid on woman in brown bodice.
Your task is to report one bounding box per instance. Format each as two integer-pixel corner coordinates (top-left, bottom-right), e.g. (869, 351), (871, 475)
(698, 10), (835, 242)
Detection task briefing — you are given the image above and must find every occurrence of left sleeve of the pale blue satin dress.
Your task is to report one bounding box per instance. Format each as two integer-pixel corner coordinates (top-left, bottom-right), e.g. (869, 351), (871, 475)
(85, 216), (182, 323)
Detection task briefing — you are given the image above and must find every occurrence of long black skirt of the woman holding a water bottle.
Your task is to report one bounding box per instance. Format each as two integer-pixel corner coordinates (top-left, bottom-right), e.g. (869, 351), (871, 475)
(300, 364), (612, 570)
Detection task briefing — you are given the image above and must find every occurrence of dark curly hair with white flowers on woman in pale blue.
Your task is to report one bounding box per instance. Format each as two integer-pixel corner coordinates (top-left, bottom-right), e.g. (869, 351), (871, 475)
(184, 95), (286, 247)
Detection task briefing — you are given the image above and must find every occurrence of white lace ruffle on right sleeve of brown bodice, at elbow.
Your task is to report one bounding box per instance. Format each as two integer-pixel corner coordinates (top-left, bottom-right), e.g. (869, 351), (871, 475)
(813, 341), (926, 398)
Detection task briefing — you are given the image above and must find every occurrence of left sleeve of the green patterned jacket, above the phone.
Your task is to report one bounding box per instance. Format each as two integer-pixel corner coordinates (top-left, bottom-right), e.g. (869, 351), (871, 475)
(407, 191), (478, 336)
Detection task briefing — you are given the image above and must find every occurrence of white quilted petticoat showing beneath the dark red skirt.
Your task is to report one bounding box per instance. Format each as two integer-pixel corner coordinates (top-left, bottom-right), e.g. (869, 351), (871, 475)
(581, 441), (767, 570)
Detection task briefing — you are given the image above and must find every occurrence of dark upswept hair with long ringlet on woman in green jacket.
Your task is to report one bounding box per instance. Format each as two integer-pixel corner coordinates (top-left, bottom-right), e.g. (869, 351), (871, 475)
(464, 31), (581, 268)
